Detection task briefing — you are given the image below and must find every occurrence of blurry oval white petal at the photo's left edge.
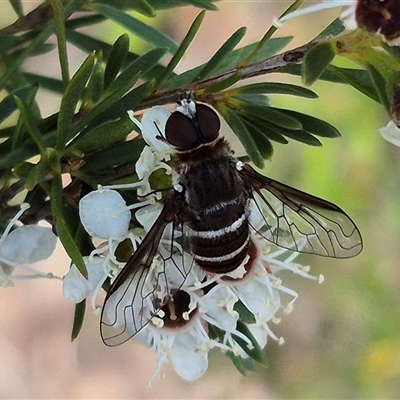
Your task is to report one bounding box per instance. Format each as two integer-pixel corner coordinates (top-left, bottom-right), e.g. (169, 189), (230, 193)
(0, 225), (57, 264)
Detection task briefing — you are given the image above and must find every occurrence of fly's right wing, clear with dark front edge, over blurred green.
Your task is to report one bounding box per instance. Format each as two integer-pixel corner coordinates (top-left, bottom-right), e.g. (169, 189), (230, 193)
(240, 164), (362, 258)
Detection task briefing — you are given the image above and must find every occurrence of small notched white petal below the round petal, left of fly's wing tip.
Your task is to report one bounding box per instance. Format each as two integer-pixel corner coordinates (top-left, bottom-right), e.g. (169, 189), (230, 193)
(62, 257), (106, 303)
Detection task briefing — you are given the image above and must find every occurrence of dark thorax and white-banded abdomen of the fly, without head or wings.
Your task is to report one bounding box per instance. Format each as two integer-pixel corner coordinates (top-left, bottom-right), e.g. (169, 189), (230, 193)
(179, 139), (250, 273)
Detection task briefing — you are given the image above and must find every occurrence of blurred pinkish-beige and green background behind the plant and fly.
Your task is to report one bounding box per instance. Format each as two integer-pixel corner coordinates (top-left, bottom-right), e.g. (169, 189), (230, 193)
(0, 1), (400, 399)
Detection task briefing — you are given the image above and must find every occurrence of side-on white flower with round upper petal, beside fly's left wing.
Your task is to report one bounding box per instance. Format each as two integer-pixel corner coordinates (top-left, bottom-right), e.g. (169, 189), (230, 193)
(77, 185), (166, 311)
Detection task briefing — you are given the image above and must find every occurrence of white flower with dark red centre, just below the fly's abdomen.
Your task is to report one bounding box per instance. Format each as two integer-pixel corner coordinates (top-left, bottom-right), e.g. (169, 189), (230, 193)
(130, 276), (241, 381)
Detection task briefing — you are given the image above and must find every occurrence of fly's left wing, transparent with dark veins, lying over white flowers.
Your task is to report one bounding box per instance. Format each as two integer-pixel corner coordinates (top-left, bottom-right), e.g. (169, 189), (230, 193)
(100, 196), (193, 346)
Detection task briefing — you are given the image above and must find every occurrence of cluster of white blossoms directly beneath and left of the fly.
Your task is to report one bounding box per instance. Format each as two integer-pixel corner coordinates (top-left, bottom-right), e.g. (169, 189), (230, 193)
(63, 107), (322, 381)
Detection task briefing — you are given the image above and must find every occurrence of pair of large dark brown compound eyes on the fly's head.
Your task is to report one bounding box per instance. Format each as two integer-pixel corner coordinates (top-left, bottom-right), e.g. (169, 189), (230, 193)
(165, 104), (221, 150)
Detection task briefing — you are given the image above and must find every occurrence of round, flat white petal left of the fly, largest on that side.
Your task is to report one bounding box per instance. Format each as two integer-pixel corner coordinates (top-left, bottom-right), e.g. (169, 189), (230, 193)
(79, 189), (131, 239)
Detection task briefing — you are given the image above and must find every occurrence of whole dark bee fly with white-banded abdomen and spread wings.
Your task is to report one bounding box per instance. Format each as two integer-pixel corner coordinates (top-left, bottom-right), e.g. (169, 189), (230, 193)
(101, 101), (362, 346)
